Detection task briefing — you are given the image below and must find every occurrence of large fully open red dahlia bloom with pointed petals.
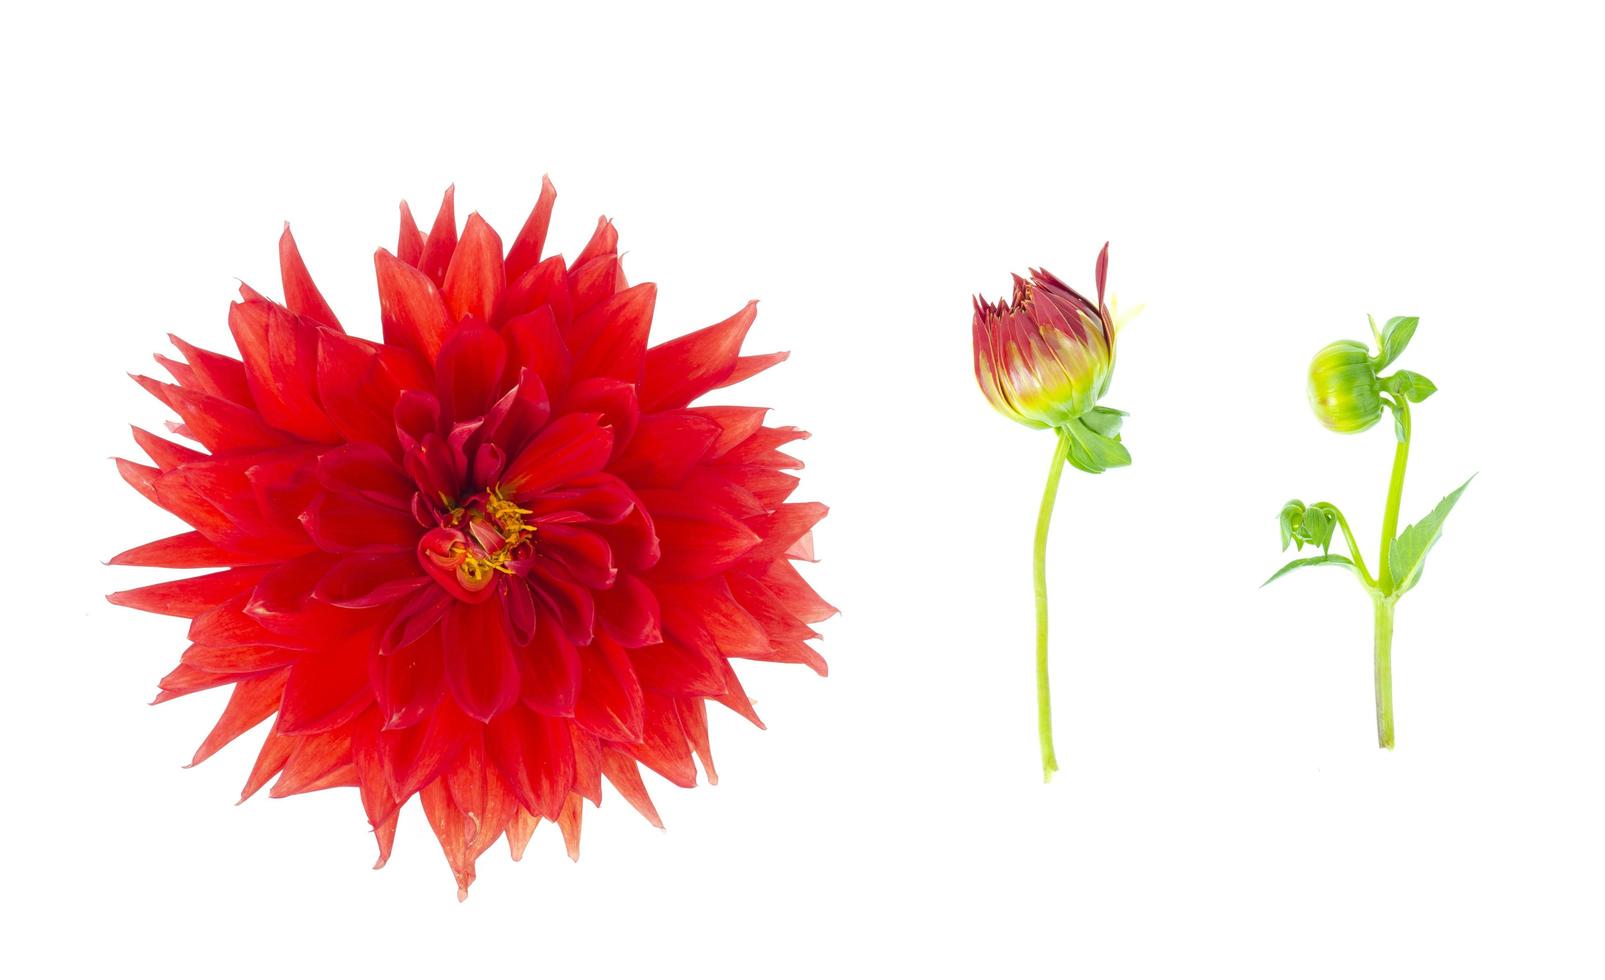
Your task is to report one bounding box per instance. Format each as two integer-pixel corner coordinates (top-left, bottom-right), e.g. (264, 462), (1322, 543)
(111, 181), (833, 895)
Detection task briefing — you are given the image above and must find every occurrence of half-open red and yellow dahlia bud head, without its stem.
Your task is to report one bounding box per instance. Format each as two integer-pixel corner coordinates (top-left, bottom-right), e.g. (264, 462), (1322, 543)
(973, 245), (1115, 428)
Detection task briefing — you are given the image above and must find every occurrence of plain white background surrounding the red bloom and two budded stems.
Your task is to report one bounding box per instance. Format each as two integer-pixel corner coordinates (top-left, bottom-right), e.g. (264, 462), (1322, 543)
(0, 3), (1605, 977)
